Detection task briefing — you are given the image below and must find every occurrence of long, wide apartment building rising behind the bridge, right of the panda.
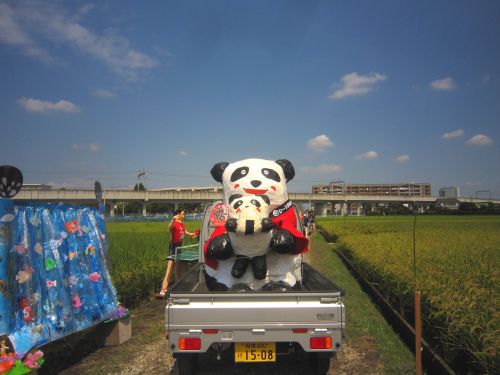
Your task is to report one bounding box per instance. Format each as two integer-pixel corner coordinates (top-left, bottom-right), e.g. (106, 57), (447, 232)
(312, 183), (432, 197)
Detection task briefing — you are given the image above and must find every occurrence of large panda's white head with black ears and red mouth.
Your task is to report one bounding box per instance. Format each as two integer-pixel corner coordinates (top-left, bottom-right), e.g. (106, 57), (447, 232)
(212, 159), (295, 209)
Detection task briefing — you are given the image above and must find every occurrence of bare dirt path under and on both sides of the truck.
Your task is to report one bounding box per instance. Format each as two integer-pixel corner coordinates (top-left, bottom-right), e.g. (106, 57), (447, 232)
(39, 299), (383, 375)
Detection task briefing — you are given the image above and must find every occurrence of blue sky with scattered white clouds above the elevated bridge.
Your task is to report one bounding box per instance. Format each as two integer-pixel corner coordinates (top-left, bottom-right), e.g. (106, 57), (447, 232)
(0, 0), (500, 198)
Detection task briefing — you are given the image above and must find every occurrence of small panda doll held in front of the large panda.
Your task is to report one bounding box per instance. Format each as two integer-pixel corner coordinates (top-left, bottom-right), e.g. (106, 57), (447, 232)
(226, 194), (273, 280)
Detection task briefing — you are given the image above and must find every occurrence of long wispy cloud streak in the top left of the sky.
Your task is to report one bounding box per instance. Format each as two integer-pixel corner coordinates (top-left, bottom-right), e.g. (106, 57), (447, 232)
(0, 2), (160, 80)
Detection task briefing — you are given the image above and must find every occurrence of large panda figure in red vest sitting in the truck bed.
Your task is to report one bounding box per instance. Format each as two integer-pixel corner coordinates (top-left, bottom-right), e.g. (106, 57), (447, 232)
(204, 159), (308, 290)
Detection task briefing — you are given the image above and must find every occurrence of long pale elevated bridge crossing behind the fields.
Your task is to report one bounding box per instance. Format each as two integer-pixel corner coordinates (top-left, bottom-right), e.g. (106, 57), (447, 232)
(14, 188), (500, 215)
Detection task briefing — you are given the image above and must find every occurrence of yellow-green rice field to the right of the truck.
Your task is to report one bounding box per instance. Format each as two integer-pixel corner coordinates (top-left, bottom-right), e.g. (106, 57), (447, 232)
(318, 216), (500, 373)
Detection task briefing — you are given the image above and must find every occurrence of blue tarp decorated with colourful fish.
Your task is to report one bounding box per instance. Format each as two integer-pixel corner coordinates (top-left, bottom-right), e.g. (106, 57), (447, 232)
(0, 204), (118, 353)
